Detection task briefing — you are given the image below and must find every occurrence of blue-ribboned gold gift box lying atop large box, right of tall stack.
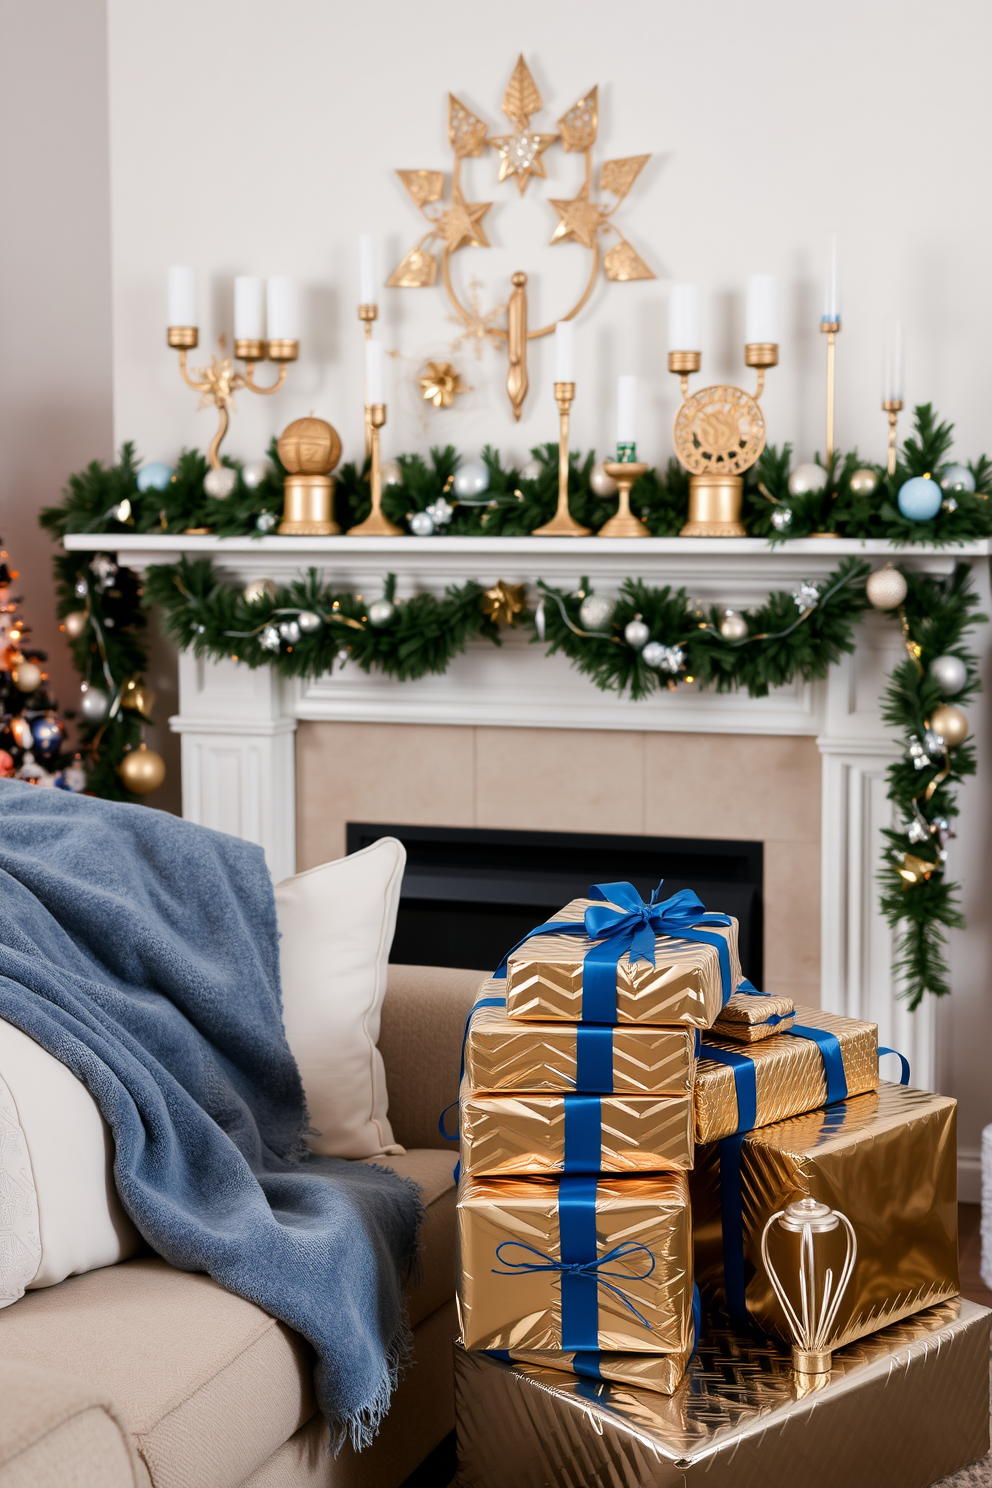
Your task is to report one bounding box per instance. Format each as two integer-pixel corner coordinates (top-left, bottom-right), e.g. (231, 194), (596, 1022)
(693, 1007), (879, 1143)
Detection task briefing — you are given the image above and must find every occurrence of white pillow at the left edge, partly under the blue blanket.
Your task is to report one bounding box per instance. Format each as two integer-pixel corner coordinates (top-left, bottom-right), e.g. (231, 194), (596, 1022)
(0, 1019), (141, 1306)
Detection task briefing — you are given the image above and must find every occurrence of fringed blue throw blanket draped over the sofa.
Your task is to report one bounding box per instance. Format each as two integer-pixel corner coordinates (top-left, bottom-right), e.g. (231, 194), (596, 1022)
(0, 780), (419, 1446)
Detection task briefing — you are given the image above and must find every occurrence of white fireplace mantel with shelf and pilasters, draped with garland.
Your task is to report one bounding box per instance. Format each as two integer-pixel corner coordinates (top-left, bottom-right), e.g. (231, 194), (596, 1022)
(65, 534), (992, 1088)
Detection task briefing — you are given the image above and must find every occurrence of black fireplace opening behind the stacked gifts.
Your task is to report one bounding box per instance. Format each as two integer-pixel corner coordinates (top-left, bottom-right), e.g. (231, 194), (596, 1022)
(347, 821), (764, 987)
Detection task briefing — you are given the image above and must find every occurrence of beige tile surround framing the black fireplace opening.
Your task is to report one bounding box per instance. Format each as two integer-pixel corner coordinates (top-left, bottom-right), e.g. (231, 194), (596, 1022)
(296, 723), (819, 1006)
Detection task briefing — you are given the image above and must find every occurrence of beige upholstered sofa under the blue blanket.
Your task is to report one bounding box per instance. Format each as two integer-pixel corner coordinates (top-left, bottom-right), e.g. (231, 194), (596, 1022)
(0, 966), (482, 1488)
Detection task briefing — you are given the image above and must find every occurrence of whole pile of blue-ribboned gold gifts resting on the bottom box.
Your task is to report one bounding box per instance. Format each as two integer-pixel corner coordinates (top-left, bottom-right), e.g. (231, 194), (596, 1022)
(458, 884), (958, 1394)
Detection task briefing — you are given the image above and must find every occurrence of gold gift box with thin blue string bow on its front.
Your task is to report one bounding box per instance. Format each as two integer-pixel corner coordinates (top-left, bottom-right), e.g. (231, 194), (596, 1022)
(457, 1173), (693, 1354)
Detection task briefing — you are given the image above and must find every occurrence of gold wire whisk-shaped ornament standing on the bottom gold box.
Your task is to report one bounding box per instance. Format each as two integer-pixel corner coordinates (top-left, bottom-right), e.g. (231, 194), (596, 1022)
(761, 1198), (858, 1375)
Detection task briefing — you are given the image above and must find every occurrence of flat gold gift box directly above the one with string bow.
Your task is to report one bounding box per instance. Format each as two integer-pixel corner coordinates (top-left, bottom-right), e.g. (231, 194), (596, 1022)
(461, 1094), (693, 1178)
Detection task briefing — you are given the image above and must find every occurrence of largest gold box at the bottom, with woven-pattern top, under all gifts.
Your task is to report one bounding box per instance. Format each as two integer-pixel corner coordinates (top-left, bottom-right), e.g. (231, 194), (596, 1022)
(455, 1301), (992, 1488)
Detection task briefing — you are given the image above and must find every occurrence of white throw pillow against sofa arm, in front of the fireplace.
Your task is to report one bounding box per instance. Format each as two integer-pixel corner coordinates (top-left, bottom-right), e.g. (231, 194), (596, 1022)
(275, 838), (406, 1158)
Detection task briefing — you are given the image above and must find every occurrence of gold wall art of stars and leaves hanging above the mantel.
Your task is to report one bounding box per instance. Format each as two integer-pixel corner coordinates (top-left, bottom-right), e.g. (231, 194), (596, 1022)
(387, 55), (654, 420)
